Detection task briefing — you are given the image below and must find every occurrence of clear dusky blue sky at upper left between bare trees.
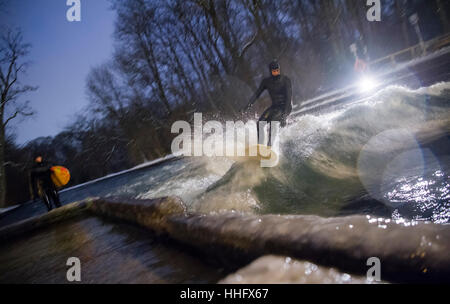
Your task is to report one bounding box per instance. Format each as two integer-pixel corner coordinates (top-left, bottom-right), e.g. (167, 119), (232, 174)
(0, 0), (115, 144)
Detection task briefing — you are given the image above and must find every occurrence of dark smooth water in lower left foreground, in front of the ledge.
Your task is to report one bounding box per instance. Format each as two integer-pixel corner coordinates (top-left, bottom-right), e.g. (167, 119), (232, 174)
(0, 215), (226, 284)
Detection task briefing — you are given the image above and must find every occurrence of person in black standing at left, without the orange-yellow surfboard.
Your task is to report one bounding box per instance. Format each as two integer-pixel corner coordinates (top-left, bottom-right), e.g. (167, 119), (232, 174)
(29, 155), (61, 211)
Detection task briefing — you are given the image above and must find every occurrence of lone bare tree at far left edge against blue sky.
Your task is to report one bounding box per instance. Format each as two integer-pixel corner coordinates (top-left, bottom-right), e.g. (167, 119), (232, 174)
(0, 30), (37, 206)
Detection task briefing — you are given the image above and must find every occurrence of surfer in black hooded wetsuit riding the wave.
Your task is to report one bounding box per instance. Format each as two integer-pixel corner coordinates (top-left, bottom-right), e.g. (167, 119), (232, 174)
(243, 60), (292, 147)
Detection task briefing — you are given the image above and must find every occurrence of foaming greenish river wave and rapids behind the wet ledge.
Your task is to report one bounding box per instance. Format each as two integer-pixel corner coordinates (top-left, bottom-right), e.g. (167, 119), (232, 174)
(54, 83), (450, 224)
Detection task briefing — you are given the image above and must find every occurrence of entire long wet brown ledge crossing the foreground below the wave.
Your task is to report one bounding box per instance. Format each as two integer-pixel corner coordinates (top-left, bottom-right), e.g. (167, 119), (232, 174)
(0, 197), (450, 282)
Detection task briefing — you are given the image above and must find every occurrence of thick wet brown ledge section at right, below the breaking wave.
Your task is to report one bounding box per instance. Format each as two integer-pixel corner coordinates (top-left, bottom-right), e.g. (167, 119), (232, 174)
(168, 210), (450, 282)
